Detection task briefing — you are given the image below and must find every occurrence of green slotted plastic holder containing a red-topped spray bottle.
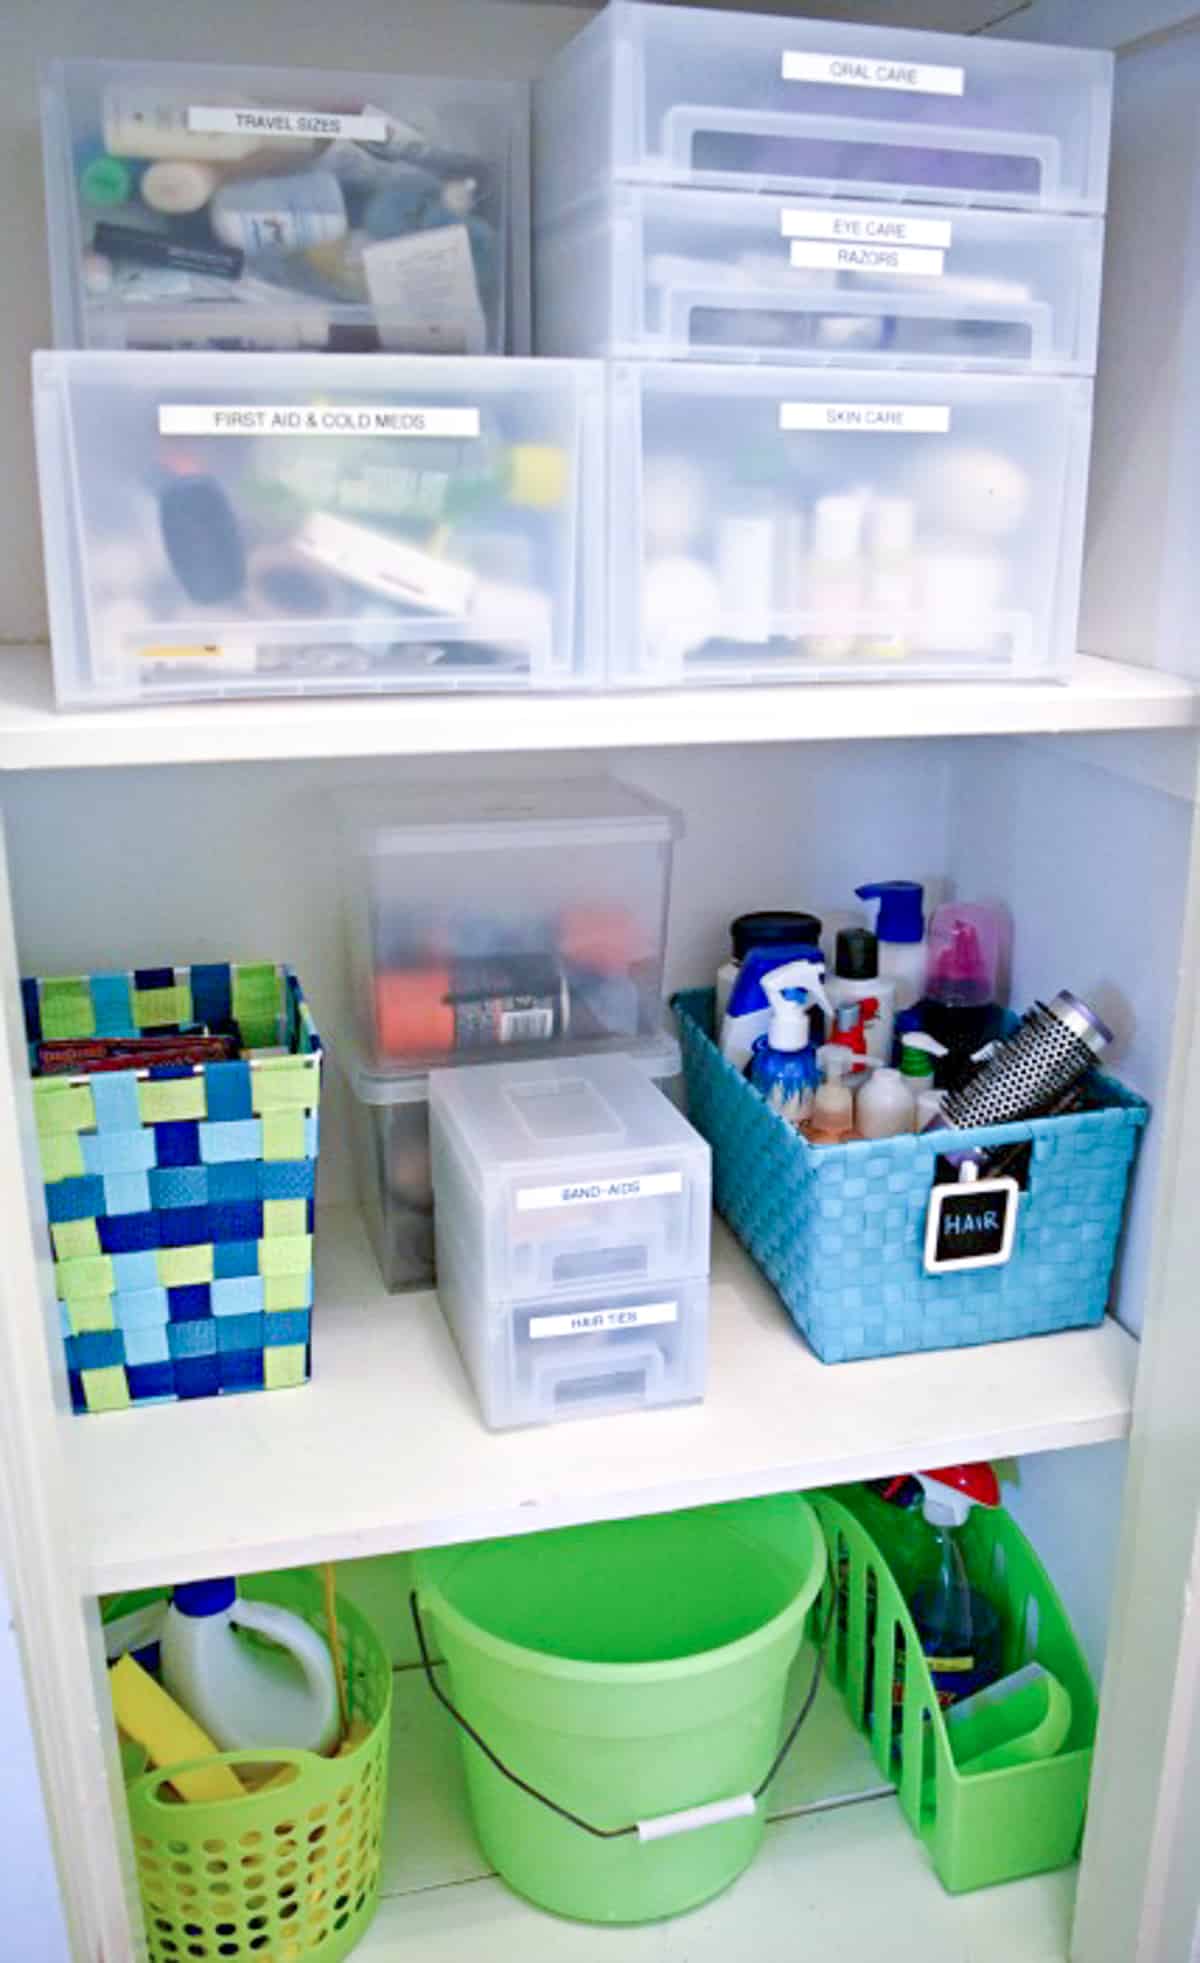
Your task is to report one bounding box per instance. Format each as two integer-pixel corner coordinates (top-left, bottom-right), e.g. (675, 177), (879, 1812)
(809, 1486), (1096, 1894)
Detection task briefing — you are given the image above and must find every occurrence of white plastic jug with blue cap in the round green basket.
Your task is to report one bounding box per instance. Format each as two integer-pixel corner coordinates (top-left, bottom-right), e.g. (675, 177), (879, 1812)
(161, 1580), (340, 1751)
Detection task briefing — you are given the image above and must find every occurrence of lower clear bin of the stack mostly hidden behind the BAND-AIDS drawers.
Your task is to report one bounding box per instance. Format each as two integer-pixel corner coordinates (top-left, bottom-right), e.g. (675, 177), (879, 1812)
(350, 1036), (680, 1290)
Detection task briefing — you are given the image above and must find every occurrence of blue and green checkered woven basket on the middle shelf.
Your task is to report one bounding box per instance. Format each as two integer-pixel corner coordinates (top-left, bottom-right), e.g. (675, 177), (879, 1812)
(22, 962), (322, 1411)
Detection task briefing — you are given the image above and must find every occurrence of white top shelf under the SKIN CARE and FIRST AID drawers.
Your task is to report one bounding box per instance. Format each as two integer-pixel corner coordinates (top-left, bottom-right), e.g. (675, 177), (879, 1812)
(0, 648), (1200, 771)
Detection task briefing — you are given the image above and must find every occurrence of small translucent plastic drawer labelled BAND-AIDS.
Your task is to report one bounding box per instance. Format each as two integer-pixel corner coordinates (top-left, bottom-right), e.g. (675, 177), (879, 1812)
(430, 1054), (711, 1311)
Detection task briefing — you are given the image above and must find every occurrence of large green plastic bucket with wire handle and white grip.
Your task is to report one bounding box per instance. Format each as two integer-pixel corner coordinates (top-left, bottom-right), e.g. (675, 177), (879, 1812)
(416, 1494), (825, 1922)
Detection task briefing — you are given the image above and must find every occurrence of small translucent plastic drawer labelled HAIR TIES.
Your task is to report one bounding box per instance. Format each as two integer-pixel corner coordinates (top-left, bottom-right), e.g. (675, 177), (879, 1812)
(438, 1231), (709, 1429)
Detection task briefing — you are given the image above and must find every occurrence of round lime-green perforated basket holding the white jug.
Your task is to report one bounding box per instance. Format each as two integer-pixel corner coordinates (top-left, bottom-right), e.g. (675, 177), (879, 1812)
(112, 1570), (391, 1963)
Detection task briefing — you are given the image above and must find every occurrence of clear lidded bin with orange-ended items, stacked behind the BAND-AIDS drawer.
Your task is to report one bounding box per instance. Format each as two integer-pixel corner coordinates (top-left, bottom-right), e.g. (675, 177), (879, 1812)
(340, 777), (682, 1070)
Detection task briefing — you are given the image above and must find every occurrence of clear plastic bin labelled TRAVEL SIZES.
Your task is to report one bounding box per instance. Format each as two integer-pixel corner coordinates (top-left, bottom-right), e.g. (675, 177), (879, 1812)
(41, 61), (528, 355)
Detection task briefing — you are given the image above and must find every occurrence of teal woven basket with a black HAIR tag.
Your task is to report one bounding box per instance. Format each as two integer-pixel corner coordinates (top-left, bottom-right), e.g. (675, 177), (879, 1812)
(674, 989), (1149, 1362)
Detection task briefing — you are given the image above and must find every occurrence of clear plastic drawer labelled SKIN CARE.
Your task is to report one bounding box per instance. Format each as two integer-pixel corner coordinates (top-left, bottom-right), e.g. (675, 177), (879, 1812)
(611, 361), (1092, 685)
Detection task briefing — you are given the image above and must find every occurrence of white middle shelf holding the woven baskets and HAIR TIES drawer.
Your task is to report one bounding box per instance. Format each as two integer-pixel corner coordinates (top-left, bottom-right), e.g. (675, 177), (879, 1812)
(70, 1209), (1137, 1592)
